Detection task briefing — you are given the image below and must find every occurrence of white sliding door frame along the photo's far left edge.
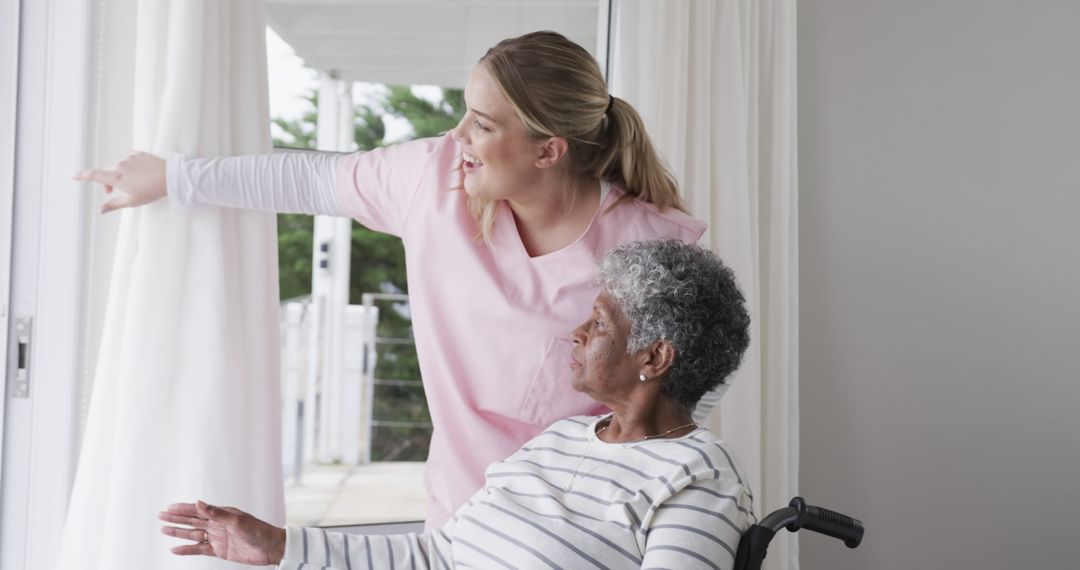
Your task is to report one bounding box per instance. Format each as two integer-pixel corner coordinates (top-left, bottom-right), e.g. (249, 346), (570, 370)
(0, 0), (93, 568)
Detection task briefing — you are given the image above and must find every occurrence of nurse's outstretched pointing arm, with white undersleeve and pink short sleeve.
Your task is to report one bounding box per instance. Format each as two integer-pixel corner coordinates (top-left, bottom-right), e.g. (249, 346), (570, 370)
(75, 136), (447, 236)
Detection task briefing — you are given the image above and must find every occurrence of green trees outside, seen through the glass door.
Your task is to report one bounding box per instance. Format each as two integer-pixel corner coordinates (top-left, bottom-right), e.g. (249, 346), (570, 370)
(273, 86), (464, 461)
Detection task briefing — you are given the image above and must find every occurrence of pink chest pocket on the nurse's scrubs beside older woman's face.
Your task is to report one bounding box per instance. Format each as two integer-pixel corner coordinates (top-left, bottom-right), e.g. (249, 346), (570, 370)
(521, 338), (600, 426)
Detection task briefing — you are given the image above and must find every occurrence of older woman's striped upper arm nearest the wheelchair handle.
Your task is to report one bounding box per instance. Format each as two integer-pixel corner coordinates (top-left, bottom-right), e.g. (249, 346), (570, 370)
(642, 480), (754, 570)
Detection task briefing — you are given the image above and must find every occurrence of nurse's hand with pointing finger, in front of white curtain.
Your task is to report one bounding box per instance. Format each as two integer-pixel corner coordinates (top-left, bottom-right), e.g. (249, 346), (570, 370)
(72, 152), (166, 214)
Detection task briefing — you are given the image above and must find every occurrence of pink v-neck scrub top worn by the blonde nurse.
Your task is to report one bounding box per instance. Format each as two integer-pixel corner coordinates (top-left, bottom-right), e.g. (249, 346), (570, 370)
(335, 136), (705, 528)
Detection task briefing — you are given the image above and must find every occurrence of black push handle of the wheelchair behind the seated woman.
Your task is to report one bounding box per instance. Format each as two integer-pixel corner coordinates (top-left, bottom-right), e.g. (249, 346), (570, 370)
(734, 497), (863, 570)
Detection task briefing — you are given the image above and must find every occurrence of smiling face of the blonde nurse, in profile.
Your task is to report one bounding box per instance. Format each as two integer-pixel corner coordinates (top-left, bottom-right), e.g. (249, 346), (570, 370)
(450, 64), (539, 200)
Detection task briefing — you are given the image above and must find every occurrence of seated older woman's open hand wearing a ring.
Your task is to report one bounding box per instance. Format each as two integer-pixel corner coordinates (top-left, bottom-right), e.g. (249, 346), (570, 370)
(158, 501), (285, 566)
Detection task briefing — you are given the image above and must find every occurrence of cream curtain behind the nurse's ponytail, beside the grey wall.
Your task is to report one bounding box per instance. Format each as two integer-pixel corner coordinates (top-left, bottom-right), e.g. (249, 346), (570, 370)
(611, 0), (798, 570)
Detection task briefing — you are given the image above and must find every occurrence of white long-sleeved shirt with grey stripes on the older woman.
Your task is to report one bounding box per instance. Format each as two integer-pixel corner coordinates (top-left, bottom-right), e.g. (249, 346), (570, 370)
(280, 417), (755, 570)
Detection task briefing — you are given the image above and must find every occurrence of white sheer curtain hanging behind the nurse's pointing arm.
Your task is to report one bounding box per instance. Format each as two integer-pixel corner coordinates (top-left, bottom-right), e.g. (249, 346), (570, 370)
(59, 0), (284, 570)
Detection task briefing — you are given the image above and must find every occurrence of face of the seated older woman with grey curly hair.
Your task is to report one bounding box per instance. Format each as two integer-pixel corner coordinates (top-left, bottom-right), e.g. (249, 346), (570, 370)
(570, 293), (638, 403)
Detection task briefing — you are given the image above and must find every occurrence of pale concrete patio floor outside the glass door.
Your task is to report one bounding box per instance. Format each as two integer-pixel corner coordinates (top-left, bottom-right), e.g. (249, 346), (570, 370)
(285, 461), (428, 527)
